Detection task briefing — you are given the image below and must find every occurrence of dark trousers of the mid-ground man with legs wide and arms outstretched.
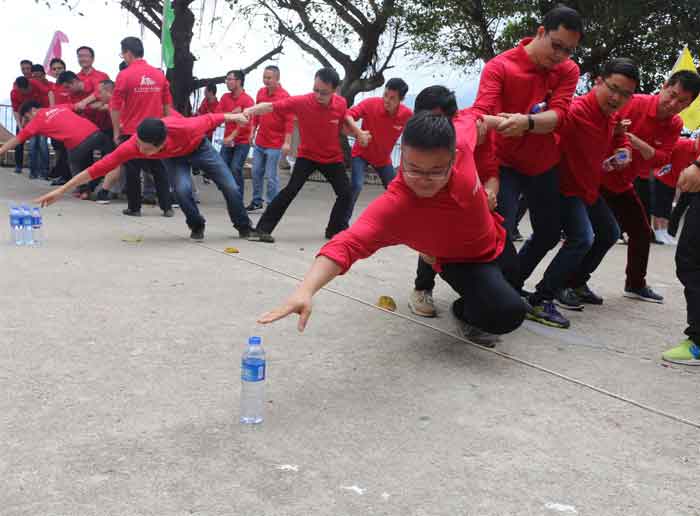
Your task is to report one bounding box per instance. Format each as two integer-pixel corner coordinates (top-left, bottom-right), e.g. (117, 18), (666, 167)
(257, 158), (351, 237)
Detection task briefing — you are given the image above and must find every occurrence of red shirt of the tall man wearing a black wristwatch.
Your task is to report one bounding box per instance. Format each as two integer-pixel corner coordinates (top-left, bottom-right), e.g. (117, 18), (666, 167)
(472, 38), (579, 176)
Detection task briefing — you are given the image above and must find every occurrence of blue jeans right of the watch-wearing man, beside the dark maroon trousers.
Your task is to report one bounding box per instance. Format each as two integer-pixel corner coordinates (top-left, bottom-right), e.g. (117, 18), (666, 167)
(537, 195), (620, 299)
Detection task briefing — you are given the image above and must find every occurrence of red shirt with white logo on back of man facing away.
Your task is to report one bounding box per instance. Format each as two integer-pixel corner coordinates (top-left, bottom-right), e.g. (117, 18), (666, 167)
(109, 59), (172, 135)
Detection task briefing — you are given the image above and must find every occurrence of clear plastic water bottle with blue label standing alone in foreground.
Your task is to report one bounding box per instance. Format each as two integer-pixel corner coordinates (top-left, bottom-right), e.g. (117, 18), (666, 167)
(241, 337), (265, 424)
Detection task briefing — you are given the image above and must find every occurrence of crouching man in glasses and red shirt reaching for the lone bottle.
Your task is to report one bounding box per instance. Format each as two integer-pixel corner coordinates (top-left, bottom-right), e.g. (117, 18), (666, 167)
(258, 111), (525, 343)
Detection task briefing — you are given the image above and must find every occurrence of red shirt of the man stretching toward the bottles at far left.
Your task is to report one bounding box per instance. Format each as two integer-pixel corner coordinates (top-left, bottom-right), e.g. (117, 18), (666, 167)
(88, 113), (224, 179)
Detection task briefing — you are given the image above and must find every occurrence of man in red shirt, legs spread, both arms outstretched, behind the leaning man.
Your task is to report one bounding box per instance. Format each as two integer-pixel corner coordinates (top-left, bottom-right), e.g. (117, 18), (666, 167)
(244, 68), (369, 243)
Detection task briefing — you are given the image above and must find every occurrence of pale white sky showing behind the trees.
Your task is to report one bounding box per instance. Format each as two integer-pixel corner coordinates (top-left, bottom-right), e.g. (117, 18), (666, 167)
(0, 0), (478, 107)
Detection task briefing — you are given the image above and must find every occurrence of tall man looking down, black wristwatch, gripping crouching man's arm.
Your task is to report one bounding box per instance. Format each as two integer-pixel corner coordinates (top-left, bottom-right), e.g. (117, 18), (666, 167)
(473, 6), (583, 326)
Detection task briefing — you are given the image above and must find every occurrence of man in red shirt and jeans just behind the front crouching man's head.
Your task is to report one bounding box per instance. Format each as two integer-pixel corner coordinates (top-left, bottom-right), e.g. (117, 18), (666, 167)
(347, 78), (413, 223)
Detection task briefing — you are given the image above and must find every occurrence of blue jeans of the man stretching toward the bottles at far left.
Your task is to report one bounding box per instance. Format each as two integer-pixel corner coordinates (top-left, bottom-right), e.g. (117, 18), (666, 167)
(163, 138), (252, 230)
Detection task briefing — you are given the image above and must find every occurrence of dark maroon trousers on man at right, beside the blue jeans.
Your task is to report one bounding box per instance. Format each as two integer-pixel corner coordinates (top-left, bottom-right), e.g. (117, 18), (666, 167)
(600, 188), (651, 289)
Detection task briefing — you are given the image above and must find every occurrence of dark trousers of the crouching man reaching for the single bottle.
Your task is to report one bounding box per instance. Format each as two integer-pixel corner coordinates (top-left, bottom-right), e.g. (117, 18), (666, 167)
(440, 241), (526, 335)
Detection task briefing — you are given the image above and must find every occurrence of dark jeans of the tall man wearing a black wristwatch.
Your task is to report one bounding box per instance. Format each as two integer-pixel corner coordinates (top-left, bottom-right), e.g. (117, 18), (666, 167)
(497, 167), (561, 288)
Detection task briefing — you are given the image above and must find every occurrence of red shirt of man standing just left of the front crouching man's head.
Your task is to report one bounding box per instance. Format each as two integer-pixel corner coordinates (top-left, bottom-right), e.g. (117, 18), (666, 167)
(348, 97), (413, 167)
